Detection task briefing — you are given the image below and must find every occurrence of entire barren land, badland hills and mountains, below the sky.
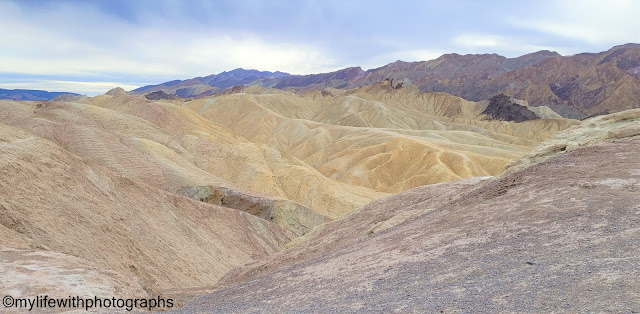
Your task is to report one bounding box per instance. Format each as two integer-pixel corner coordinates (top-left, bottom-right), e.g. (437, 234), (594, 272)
(0, 3), (640, 313)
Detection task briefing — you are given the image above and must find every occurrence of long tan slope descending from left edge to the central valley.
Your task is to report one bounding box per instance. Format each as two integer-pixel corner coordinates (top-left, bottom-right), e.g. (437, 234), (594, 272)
(0, 95), (384, 217)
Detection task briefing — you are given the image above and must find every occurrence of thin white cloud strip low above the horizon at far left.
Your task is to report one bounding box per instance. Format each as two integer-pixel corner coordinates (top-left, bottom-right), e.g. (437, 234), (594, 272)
(0, 80), (142, 96)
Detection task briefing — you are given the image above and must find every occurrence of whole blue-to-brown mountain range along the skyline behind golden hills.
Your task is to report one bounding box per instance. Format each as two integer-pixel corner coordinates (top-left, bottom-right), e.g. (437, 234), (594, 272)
(133, 44), (640, 119)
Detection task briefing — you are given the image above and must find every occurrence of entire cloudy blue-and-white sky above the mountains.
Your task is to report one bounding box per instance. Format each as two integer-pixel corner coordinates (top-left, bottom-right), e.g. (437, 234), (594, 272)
(0, 0), (640, 96)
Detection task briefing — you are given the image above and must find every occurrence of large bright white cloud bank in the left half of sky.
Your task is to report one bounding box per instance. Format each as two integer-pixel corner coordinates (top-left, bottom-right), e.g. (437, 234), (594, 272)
(0, 2), (339, 82)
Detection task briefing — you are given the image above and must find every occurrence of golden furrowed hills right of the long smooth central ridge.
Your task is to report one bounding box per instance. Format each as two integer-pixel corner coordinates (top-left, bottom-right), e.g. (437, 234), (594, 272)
(184, 82), (576, 192)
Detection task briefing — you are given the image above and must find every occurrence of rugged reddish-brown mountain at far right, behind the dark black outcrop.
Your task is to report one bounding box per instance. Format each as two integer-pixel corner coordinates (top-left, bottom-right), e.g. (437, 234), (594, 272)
(482, 44), (640, 118)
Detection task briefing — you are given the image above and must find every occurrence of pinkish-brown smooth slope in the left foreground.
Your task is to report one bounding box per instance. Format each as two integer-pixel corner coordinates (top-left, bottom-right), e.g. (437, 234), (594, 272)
(0, 124), (292, 293)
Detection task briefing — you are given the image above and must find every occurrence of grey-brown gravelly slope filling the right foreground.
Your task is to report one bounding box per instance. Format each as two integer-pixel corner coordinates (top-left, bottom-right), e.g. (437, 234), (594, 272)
(179, 111), (640, 313)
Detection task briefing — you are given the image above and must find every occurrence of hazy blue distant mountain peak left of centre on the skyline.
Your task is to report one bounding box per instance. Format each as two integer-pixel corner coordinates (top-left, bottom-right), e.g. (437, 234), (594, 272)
(131, 69), (291, 97)
